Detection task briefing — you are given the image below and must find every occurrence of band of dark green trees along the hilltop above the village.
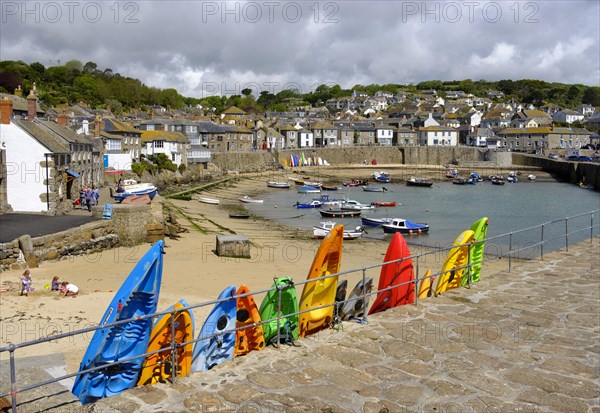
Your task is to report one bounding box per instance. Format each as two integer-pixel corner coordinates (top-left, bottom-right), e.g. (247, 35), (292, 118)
(0, 60), (600, 113)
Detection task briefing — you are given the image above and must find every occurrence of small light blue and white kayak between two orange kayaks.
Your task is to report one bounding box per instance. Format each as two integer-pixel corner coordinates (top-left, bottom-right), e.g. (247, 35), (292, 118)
(192, 286), (237, 372)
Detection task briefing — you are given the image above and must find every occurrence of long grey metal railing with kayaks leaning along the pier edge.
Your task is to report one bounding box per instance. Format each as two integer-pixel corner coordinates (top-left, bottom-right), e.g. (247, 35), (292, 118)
(0, 210), (600, 412)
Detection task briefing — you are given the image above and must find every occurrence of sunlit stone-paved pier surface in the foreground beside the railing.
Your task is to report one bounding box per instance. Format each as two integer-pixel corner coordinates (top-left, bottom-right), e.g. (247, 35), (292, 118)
(1, 238), (600, 413)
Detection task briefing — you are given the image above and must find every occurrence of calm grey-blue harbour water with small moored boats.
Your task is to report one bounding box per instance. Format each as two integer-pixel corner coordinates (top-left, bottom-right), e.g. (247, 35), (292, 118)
(245, 181), (600, 258)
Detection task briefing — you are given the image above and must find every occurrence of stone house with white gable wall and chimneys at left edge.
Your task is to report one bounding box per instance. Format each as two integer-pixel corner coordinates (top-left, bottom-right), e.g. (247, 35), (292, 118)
(0, 88), (95, 214)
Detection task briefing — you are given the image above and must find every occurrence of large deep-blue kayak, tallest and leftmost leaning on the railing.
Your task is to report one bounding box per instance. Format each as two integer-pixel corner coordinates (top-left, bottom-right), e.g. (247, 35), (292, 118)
(71, 241), (164, 404)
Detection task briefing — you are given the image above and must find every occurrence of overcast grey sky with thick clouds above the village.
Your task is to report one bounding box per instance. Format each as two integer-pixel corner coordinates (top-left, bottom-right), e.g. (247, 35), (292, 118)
(0, 0), (600, 97)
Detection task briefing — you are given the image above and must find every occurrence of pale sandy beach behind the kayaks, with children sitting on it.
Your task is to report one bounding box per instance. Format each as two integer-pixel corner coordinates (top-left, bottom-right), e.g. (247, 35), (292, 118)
(0, 168), (506, 372)
